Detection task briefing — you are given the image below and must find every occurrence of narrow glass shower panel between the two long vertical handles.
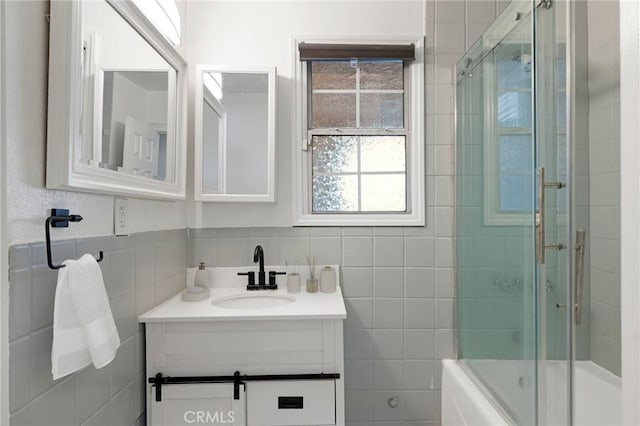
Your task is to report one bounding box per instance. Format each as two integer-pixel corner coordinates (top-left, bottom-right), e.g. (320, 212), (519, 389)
(534, 0), (572, 425)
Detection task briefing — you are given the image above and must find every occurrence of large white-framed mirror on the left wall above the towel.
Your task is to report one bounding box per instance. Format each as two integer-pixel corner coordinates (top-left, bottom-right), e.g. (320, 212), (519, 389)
(47, 0), (186, 199)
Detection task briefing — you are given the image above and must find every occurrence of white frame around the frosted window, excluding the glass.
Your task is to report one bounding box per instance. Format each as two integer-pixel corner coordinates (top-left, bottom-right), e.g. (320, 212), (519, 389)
(292, 36), (426, 226)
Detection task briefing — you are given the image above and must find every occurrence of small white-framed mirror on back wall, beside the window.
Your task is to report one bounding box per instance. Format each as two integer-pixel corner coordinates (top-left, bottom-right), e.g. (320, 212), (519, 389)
(195, 65), (276, 202)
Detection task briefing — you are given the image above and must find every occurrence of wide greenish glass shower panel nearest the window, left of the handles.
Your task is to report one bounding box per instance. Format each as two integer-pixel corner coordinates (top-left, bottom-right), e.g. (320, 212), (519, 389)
(456, 1), (538, 425)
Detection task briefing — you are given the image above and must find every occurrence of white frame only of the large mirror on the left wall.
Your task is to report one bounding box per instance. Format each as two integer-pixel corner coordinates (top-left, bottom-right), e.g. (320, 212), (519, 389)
(46, 0), (187, 199)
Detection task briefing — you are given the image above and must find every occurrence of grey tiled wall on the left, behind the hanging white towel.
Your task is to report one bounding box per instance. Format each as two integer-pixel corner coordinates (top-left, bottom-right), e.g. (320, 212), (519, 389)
(9, 230), (187, 426)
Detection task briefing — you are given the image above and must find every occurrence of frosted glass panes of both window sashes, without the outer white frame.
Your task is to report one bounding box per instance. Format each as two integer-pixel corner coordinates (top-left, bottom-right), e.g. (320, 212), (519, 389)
(307, 60), (407, 213)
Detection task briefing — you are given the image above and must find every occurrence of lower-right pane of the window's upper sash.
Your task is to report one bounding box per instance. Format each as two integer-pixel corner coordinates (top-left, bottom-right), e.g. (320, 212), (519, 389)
(360, 93), (404, 129)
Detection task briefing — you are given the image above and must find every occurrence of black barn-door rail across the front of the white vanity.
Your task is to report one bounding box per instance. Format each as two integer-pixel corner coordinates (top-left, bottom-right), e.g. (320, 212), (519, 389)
(149, 371), (340, 402)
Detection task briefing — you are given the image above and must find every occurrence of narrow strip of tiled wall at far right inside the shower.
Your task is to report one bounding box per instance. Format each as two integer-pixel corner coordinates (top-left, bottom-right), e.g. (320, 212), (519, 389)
(588, 1), (621, 375)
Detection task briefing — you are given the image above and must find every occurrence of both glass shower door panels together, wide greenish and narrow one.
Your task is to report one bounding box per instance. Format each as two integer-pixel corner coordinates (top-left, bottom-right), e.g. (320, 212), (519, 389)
(456, 0), (577, 425)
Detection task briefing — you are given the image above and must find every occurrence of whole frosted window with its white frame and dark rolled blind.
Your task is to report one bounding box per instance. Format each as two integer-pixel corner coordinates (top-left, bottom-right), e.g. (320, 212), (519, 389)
(294, 43), (424, 226)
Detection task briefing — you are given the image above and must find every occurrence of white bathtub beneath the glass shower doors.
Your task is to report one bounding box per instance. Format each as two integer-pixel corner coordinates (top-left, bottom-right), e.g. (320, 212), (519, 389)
(442, 360), (622, 426)
